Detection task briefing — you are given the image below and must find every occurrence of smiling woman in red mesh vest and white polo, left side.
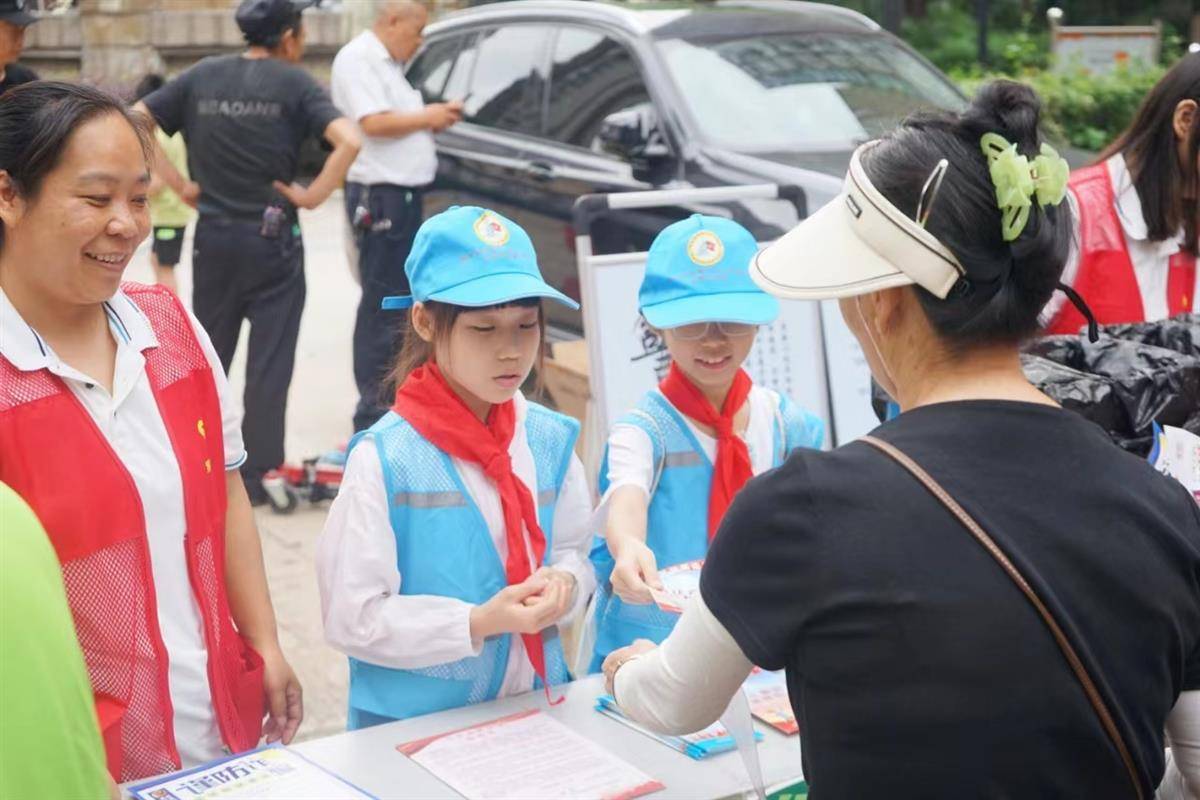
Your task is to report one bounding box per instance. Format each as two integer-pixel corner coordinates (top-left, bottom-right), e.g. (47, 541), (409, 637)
(0, 82), (302, 781)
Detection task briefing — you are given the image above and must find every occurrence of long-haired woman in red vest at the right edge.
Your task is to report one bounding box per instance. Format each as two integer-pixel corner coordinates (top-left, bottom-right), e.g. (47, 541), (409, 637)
(1043, 53), (1200, 333)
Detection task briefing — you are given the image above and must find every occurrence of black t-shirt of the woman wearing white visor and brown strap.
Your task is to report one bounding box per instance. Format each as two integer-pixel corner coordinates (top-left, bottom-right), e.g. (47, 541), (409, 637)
(701, 401), (1200, 800)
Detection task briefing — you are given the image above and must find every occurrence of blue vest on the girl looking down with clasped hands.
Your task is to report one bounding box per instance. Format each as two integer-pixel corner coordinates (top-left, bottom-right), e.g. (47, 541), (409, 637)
(347, 403), (580, 730)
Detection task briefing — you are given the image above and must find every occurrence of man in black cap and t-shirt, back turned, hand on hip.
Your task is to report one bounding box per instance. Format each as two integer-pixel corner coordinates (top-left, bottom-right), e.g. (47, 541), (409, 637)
(140, 0), (361, 504)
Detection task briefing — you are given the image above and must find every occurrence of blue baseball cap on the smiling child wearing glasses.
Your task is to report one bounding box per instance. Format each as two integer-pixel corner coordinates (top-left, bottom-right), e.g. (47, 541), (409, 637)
(637, 213), (779, 329)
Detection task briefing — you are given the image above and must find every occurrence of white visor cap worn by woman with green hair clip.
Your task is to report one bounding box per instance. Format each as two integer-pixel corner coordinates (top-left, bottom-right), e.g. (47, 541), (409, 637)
(750, 142), (966, 300)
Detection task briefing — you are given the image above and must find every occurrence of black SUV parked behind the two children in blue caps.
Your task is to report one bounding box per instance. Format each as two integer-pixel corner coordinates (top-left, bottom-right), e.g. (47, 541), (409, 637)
(408, 0), (964, 331)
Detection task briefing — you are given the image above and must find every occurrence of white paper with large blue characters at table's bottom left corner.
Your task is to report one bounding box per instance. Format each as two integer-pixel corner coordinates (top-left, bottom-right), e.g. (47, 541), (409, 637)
(128, 745), (374, 800)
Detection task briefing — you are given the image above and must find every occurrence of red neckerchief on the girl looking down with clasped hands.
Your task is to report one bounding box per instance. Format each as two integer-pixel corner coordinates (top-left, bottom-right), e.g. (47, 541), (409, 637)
(391, 363), (562, 702)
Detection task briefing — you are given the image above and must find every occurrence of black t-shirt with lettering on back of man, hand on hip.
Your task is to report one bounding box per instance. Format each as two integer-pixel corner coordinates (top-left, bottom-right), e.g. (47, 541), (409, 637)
(145, 55), (341, 219)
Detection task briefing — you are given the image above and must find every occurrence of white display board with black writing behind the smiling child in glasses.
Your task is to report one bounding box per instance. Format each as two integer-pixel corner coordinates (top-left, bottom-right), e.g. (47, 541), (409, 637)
(580, 253), (878, 470)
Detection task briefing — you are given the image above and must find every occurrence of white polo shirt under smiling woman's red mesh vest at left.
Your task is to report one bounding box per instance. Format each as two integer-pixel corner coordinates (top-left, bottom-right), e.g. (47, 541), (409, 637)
(0, 289), (246, 766)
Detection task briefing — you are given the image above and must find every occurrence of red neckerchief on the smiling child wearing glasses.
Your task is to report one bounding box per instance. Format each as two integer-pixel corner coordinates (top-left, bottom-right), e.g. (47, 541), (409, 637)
(659, 361), (754, 541)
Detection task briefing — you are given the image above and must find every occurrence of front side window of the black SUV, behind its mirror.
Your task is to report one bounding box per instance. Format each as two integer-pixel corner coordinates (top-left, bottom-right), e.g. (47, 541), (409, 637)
(546, 28), (650, 151)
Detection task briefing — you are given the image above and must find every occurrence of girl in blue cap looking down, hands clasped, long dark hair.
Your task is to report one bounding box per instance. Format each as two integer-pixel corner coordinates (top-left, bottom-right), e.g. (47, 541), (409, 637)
(317, 206), (594, 729)
